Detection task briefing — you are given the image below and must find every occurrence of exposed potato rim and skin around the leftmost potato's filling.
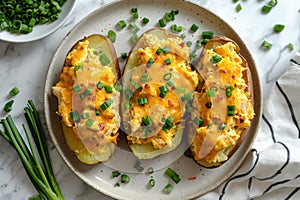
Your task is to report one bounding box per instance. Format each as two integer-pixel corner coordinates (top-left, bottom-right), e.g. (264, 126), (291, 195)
(52, 34), (120, 164)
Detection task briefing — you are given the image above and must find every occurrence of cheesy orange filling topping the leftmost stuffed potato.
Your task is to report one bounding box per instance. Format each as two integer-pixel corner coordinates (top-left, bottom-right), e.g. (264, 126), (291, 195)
(52, 39), (120, 154)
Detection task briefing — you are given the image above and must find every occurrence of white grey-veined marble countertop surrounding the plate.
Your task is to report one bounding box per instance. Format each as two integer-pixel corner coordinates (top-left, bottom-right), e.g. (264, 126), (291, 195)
(0, 0), (300, 200)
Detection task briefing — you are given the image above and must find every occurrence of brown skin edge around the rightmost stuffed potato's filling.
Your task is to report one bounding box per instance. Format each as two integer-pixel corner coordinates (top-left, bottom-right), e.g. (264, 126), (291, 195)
(187, 36), (254, 168)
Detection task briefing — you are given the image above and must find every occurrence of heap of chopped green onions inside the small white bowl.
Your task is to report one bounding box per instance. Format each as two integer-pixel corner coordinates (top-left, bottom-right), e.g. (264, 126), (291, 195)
(0, 0), (66, 34)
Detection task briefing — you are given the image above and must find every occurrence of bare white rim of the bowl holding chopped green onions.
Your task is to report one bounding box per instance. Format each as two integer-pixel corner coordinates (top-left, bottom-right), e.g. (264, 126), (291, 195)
(0, 0), (76, 43)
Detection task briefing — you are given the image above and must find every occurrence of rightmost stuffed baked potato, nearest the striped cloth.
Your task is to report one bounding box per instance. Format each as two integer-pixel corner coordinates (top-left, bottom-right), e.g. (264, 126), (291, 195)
(188, 36), (255, 168)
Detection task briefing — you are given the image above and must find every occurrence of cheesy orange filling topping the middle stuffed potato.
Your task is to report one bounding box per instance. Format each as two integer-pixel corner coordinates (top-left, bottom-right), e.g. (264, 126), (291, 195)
(125, 34), (199, 149)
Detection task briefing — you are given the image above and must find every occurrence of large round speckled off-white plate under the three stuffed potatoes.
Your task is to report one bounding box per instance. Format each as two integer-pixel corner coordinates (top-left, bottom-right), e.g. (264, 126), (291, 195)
(45, 0), (261, 200)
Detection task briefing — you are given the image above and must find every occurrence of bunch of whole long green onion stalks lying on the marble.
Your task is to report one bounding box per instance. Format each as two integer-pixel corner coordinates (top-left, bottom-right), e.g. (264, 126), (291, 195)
(0, 100), (64, 200)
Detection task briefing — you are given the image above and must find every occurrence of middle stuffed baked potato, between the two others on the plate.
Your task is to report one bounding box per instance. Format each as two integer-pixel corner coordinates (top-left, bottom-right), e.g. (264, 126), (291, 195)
(121, 28), (199, 159)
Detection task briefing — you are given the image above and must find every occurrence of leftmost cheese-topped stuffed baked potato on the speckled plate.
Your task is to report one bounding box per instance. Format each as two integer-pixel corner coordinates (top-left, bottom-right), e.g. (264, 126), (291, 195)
(52, 34), (121, 164)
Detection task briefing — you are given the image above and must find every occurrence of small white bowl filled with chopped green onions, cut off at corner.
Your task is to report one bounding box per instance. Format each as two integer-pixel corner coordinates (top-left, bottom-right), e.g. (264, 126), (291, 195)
(0, 0), (76, 43)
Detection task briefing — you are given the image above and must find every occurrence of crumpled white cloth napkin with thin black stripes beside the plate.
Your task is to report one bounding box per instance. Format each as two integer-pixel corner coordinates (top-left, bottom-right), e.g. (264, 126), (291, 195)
(198, 54), (300, 200)
